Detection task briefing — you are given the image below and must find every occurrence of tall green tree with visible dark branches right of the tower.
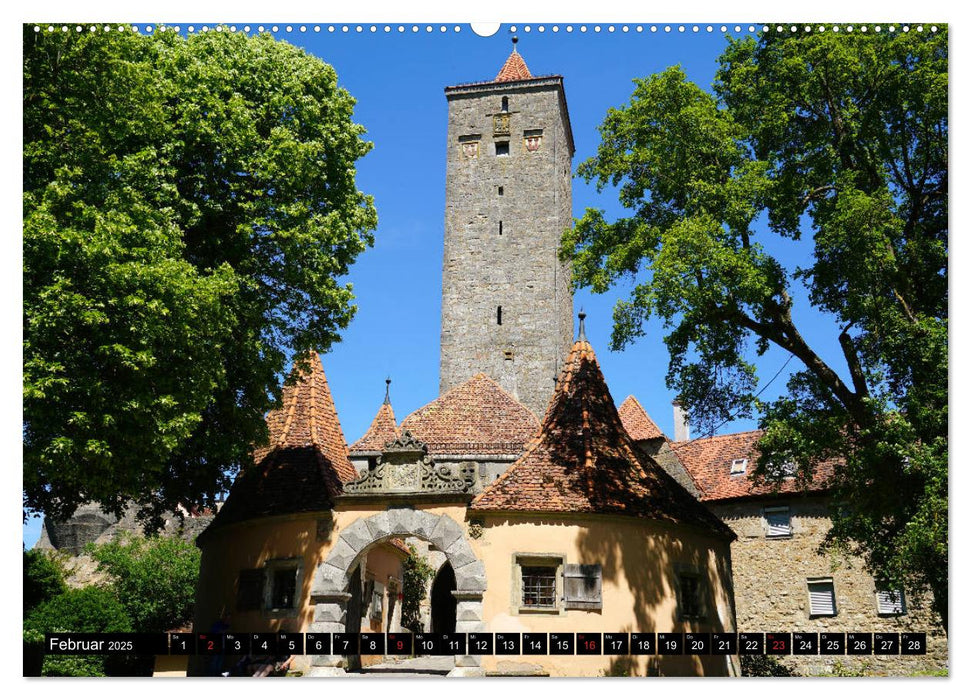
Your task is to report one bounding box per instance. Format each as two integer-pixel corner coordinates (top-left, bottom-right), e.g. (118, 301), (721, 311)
(563, 28), (948, 626)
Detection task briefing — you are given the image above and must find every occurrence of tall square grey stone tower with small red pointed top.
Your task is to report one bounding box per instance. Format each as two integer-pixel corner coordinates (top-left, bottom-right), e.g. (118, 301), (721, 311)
(439, 39), (574, 419)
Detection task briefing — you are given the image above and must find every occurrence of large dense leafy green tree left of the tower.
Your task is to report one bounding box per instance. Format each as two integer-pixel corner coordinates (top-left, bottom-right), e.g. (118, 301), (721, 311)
(23, 25), (377, 524)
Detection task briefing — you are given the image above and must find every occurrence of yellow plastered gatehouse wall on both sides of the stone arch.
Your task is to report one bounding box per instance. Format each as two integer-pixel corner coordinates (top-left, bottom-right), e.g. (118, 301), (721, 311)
(190, 505), (737, 676)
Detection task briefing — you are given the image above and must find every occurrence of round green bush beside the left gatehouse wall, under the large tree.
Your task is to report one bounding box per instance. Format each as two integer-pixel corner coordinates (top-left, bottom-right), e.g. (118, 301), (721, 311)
(86, 536), (200, 632)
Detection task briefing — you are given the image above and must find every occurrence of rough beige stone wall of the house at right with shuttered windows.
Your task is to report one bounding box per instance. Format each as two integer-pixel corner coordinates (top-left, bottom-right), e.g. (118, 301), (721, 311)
(706, 496), (948, 675)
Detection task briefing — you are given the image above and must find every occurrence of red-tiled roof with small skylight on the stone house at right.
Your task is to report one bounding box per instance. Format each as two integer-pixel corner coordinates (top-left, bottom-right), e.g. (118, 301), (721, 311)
(671, 430), (835, 501)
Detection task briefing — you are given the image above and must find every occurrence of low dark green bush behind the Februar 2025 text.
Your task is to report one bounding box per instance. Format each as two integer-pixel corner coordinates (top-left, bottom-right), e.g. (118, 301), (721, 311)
(24, 586), (132, 676)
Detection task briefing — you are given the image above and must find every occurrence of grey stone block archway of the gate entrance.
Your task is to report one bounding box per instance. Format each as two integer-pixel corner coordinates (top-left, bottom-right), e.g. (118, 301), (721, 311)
(309, 508), (486, 675)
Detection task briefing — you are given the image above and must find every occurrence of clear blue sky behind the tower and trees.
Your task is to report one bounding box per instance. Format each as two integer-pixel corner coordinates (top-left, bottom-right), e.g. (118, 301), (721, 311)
(24, 22), (868, 546)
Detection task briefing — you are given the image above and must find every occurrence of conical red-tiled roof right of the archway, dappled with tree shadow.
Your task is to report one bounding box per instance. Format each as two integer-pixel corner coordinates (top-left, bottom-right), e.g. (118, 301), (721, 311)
(471, 339), (733, 537)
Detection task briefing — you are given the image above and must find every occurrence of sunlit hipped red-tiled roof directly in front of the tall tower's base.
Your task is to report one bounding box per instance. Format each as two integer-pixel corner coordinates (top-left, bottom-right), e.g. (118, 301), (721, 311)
(401, 372), (539, 455)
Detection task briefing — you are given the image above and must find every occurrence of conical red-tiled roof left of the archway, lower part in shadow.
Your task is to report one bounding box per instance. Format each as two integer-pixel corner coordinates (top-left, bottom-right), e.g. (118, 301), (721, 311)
(210, 352), (357, 528)
